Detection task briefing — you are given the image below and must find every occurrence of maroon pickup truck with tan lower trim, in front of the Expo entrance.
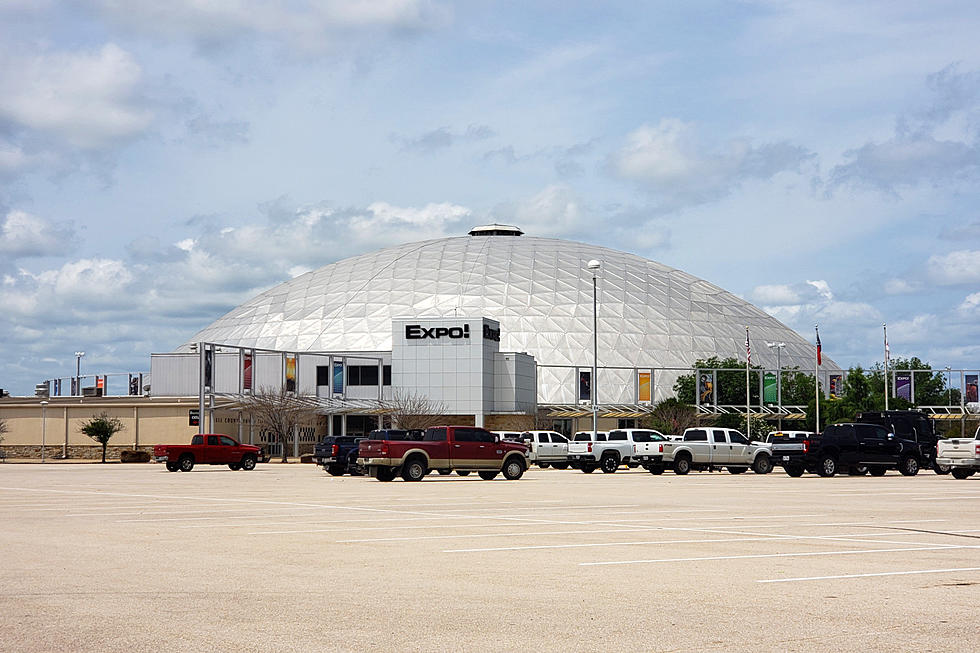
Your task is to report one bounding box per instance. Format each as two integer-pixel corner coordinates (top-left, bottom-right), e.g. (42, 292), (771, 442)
(358, 426), (527, 481)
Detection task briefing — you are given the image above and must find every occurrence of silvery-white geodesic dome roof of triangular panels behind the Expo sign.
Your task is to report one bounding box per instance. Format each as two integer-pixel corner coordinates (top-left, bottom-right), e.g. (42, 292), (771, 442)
(179, 230), (837, 403)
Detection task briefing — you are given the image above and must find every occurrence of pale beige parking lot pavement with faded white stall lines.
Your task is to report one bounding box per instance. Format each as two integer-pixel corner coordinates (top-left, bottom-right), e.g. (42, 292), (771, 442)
(0, 464), (980, 651)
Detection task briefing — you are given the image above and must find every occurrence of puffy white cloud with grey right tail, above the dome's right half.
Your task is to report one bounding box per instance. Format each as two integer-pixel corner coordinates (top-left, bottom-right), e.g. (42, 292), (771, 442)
(609, 118), (812, 203)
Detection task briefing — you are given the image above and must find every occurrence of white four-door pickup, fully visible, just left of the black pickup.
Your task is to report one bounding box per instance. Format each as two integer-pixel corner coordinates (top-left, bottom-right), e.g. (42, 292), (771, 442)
(660, 427), (772, 475)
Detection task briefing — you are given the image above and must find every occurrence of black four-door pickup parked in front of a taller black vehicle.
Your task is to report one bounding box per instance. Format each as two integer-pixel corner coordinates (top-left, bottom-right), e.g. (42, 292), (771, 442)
(778, 424), (929, 476)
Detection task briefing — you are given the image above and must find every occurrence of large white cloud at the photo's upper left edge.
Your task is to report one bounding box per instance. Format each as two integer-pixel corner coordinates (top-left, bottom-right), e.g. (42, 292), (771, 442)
(0, 43), (152, 149)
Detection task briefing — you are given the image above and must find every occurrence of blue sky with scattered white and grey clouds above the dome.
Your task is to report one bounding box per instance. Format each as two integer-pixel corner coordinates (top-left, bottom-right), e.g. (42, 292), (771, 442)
(0, 0), (980, 394)
